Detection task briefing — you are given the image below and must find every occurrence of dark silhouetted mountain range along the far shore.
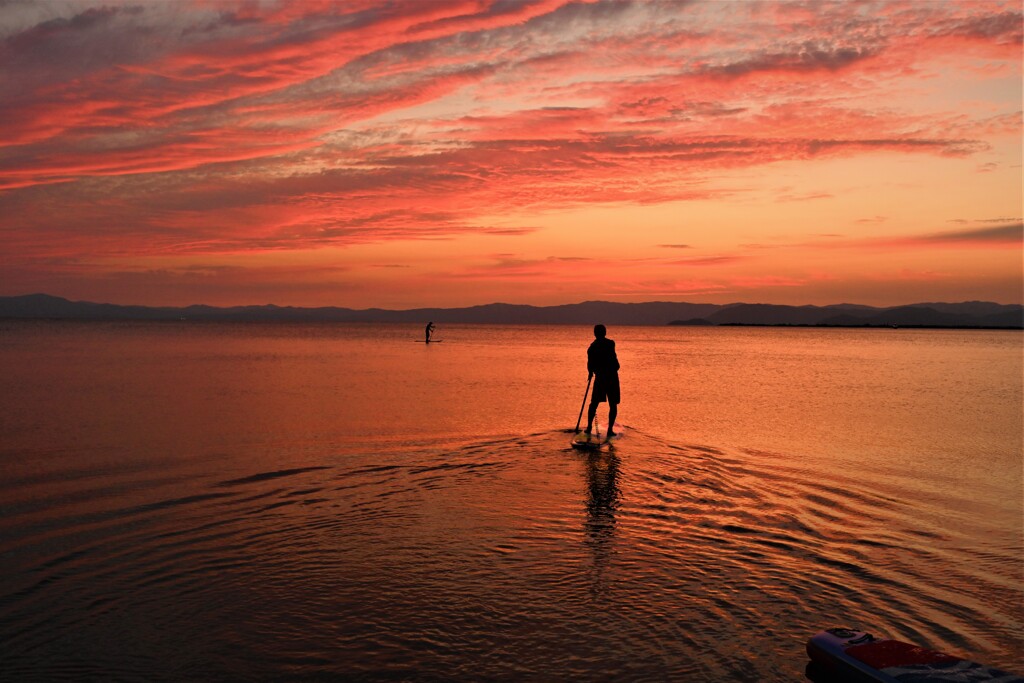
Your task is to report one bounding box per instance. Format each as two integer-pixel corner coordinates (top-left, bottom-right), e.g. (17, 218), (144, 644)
(0, 294), (1024, 329)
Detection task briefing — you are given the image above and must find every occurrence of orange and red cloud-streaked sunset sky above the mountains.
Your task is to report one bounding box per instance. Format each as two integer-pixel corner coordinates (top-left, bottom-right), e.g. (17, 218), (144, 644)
(0, 0), (1022, 308)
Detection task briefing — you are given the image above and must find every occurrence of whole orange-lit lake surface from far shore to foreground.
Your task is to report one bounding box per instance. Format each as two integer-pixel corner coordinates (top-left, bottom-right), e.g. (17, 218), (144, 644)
(0, 322), (1024, 681)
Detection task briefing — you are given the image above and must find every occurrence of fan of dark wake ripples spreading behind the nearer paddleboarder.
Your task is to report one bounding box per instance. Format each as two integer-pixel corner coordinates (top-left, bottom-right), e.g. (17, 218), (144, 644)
(0, 431), (1021, 681)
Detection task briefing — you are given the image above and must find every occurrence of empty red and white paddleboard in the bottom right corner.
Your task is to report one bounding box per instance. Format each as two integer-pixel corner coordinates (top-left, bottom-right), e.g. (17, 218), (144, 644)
(807, 629), (1024, 683)
